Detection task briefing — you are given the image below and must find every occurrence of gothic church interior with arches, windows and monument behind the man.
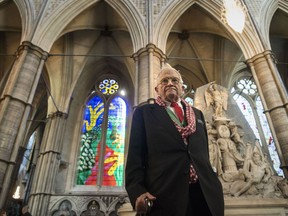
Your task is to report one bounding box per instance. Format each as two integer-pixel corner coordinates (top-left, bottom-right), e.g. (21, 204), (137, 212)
(0, 0), (288, 216)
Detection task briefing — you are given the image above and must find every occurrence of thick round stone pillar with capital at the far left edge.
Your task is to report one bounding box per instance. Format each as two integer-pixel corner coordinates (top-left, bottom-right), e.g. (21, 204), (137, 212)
(0, 42), (48, 208)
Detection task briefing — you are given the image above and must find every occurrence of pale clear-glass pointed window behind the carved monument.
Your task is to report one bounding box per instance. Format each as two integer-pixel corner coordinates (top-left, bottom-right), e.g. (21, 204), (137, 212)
(231, 76), (284, 176)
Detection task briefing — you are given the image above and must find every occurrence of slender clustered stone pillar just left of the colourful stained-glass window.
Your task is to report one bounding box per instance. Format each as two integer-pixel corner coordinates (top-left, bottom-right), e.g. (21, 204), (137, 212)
(29, 111), (67, 215)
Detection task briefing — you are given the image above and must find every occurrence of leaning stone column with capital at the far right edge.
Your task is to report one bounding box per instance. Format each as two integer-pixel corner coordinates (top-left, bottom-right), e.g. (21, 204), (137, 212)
(247, 51), (288, 178)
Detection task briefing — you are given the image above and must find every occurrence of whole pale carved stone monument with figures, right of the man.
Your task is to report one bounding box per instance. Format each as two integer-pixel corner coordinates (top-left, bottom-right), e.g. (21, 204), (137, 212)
(195, 82), (288, 198)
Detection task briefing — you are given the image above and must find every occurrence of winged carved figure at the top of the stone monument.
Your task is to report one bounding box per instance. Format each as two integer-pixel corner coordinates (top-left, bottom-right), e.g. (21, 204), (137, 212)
(205, 82), (228, 117)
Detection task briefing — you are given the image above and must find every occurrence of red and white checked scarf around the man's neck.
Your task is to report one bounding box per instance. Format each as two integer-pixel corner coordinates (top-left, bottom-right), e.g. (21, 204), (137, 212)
(156, 96), (196, 144)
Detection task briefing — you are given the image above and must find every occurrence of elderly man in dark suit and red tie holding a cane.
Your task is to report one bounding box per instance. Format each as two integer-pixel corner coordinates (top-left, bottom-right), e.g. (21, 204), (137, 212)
(126, 65), (224, 216)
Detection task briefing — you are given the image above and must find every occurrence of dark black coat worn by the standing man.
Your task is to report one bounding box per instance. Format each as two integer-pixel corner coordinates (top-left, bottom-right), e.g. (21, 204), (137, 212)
(125, 104), (224, 216)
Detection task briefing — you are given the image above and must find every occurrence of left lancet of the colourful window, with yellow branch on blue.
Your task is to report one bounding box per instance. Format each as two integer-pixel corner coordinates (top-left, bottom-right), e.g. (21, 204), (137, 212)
(77, 96), (104, 185)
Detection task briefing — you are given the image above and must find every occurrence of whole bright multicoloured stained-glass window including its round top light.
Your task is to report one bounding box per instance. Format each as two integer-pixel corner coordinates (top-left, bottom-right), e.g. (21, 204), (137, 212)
(77, 78), (127, 186)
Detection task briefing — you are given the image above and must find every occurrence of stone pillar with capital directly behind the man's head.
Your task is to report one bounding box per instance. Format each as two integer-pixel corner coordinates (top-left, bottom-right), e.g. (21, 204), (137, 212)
(132, 44), (166, 105)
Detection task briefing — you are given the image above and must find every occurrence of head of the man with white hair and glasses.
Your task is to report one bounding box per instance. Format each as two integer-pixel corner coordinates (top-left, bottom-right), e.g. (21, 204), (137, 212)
(155, 68), (184, 102)
